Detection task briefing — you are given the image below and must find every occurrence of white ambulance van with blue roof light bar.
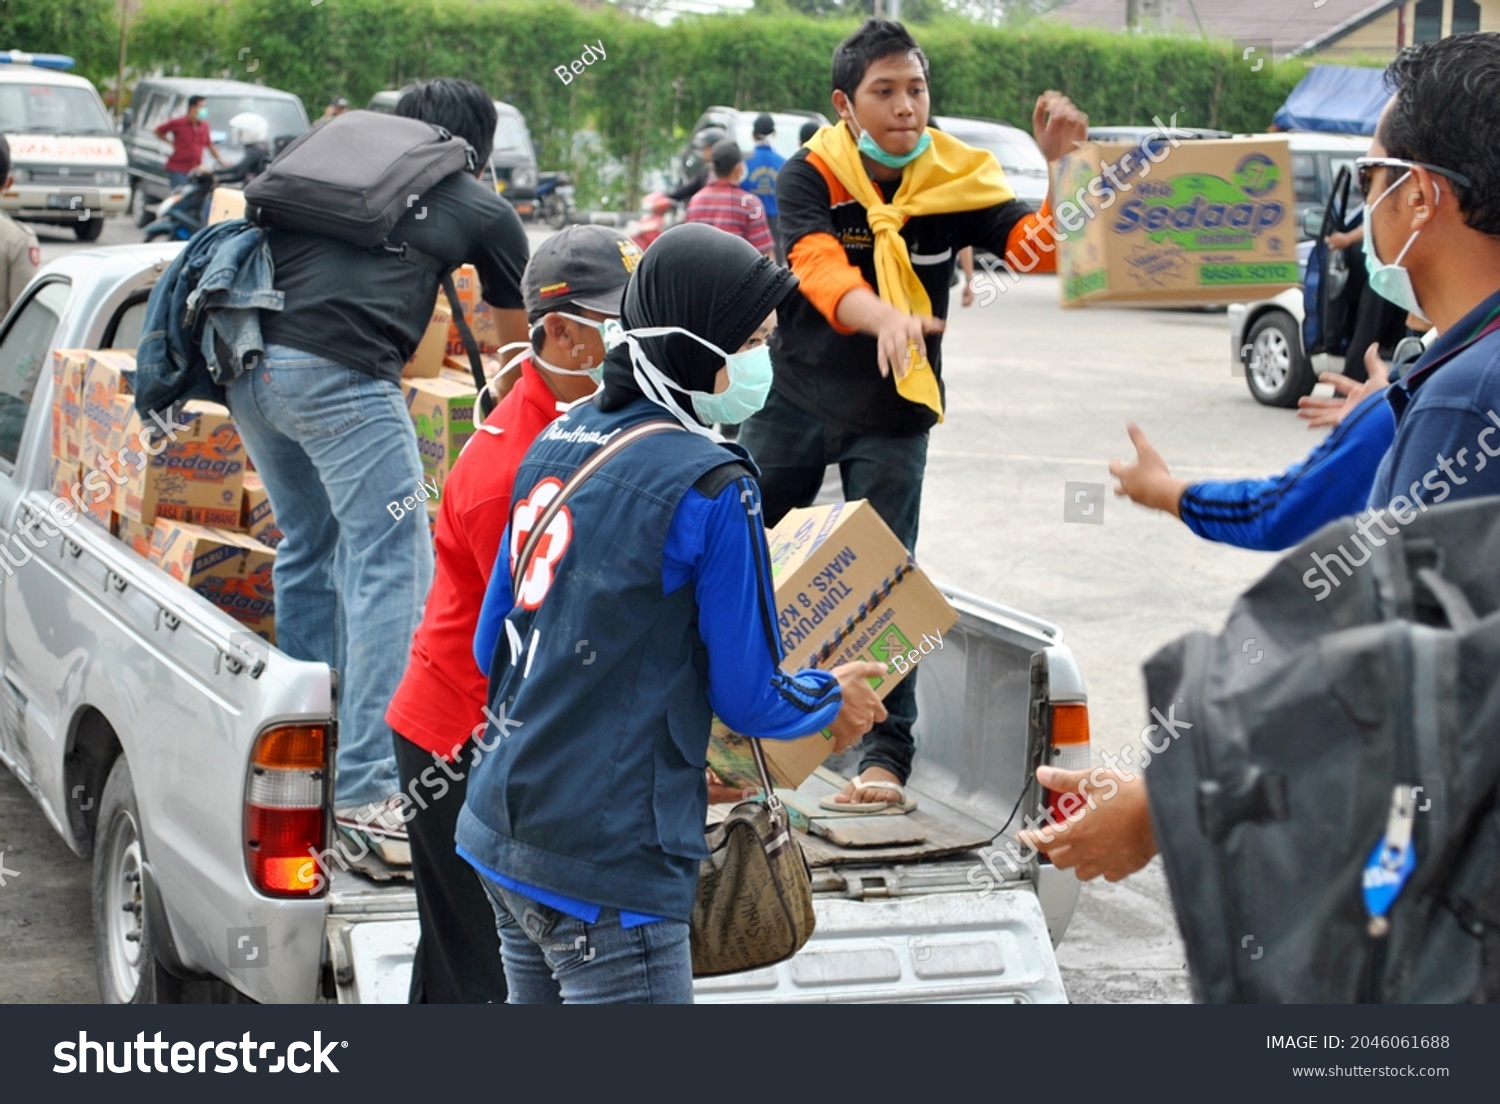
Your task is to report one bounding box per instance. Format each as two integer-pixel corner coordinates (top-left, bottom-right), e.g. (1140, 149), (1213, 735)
(0, 51), (131, 242)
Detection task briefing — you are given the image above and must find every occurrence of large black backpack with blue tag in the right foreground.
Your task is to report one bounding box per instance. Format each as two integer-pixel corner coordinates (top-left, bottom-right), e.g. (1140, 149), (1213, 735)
(1146, 498), (1500, 1004)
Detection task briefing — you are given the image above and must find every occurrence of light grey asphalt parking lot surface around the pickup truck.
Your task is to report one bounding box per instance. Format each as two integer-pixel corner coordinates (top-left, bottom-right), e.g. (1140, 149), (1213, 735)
(0, 219), (1338, 1004)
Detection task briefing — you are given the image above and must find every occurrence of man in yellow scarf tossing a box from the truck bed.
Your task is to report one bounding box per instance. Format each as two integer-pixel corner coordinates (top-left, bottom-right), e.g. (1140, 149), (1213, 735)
(740, 20), (1088, 812)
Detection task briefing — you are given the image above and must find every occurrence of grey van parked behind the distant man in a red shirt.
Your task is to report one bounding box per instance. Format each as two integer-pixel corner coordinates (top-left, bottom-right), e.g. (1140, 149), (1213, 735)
(120, 77), (308, 227)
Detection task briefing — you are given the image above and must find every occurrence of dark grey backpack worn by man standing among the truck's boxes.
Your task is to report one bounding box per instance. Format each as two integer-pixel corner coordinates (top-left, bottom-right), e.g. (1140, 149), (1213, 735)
(245, 111), (494, 414)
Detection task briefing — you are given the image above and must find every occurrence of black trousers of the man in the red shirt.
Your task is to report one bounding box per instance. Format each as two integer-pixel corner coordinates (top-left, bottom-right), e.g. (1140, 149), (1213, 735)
(395, 735), (507, 1005)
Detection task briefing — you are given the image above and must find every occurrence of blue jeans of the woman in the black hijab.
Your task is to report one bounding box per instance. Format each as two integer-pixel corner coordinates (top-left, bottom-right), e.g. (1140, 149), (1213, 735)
(476, 875), (693, 1005)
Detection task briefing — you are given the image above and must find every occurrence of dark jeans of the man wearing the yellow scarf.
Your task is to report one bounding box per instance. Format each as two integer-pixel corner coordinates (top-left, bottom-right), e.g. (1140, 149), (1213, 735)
(740, 387), (927, 782)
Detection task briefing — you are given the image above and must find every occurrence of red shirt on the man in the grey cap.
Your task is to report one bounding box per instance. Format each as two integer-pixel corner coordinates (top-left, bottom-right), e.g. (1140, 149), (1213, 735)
(386, 357), (560, 761)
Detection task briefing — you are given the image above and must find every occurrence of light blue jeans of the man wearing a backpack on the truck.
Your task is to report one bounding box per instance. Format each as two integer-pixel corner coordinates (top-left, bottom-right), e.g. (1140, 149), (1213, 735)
(228, 345), (432, 809)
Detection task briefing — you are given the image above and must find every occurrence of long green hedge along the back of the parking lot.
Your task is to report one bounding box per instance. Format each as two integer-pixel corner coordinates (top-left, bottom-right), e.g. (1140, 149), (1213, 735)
(17, 0), (1305, 201)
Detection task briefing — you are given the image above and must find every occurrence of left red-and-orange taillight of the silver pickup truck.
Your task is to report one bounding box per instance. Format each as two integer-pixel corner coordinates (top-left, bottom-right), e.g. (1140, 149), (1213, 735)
(245, 725), (329, 897)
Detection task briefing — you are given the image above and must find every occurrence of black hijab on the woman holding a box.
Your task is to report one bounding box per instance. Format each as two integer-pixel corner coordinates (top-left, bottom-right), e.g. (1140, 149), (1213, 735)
(596, 222), (797, 420)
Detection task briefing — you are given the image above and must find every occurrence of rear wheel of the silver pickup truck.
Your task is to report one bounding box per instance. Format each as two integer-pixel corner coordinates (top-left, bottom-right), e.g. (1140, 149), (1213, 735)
(93, 756), (174, 1005)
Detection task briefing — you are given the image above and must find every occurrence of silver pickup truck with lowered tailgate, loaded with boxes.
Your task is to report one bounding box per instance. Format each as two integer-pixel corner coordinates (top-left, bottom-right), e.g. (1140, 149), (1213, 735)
(0, 246), (1088, 1002)
